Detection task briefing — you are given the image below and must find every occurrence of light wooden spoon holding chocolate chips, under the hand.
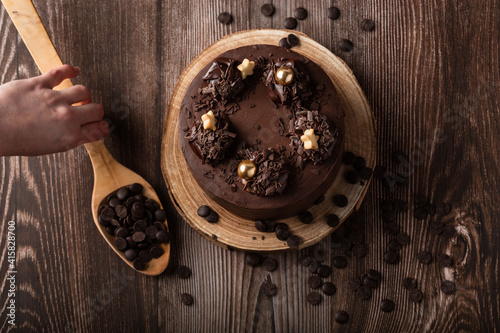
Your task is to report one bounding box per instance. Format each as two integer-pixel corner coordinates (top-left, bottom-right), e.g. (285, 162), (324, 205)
(1, 0), (170, 275)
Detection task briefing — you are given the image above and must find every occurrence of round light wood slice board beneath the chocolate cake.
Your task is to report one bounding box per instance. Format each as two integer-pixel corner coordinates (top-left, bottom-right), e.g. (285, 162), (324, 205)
(161, 29), (376, 251)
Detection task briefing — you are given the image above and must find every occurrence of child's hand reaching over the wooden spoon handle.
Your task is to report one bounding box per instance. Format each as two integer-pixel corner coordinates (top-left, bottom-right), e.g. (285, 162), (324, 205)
(0, 65), (109, 156)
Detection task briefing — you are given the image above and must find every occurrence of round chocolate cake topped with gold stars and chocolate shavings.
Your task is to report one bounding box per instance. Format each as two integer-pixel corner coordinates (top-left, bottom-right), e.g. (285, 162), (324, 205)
(179, 45), (344, 219)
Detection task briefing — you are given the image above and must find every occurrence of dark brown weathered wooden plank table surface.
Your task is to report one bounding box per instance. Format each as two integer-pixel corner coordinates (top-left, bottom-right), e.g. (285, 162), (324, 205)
(0, 0), (500, 332)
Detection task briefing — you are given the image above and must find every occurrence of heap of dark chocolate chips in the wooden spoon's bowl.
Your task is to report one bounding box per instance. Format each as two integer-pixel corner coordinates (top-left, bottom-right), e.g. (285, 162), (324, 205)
(98, 183), (170, 270)
